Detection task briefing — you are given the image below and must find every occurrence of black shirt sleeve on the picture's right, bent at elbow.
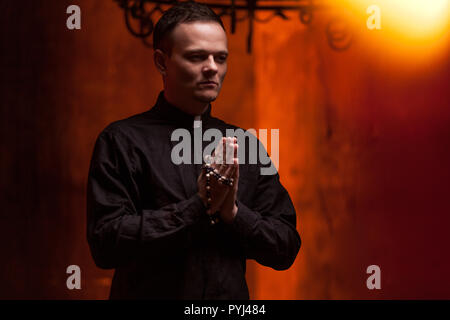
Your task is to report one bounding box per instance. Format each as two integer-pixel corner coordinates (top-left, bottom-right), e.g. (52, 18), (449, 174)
(228, 142), (301, 270)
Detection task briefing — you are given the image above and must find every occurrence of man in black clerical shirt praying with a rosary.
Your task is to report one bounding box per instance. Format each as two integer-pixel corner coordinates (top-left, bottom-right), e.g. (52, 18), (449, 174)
(87, 2), (301, 299)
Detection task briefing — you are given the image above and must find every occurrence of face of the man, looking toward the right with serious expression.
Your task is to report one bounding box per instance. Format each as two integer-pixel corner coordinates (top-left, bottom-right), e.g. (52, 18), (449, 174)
(165, 21), (228, 113)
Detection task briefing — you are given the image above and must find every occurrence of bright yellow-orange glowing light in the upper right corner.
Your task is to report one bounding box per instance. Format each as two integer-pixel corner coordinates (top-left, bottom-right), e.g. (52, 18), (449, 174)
(339, 0), (450, 66)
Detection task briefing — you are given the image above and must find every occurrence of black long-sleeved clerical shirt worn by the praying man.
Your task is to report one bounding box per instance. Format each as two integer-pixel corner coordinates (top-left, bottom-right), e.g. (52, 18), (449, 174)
(87, 92), (301, 299)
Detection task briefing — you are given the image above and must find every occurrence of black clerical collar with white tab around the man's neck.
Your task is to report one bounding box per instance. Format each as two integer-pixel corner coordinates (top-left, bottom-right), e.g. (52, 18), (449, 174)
(151, 91), (211, 128)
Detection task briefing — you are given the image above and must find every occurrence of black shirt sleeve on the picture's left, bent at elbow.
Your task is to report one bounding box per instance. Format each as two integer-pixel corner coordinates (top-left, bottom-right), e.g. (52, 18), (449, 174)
(87, 131), (205, 269)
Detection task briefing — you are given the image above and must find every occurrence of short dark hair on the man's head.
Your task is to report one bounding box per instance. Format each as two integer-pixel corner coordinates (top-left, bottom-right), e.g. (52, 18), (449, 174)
(153, 1), (225, 54)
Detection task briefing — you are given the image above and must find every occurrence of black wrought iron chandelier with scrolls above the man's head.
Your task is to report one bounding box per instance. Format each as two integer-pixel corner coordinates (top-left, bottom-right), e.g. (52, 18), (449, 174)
(114, 0), (352, 53)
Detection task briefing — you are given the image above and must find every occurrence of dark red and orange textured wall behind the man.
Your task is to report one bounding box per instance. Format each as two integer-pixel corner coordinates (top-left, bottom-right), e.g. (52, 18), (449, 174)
(0, 0), (450, 299)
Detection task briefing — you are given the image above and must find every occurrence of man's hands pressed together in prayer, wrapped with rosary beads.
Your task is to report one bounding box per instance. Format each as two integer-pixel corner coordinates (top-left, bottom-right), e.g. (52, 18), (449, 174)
(197, 137), (239, 223)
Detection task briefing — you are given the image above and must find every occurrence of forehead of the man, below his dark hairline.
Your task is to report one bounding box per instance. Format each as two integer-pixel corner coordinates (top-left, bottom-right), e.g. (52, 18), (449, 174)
(171, 21), (227, 52)
